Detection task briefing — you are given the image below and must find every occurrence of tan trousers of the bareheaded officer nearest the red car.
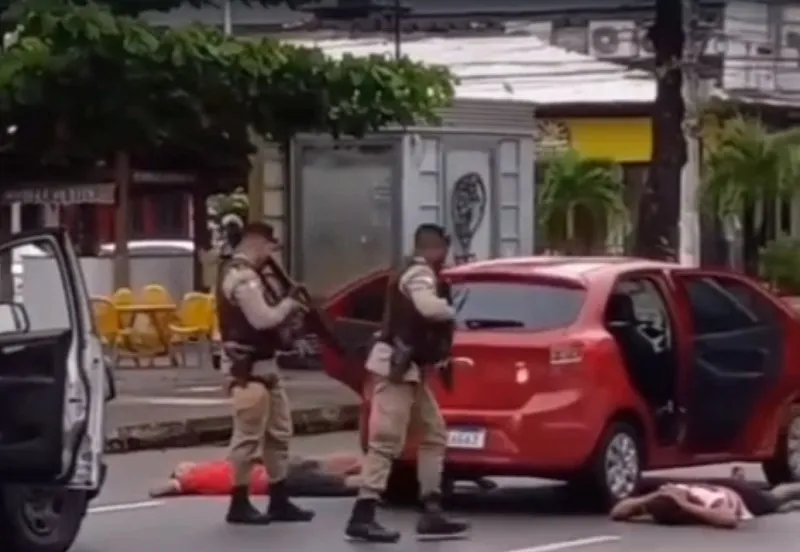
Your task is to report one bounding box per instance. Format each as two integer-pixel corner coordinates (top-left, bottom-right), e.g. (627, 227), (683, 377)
(359, 376), (447, 498)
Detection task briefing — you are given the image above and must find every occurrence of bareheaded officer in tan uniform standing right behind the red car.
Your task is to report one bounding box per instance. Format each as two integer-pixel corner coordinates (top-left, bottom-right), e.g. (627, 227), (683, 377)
(345, 224), (469, 543)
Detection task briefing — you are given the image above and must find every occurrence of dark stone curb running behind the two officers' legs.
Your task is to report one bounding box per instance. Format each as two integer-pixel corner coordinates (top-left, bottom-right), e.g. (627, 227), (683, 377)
(105, 404), (361, 454)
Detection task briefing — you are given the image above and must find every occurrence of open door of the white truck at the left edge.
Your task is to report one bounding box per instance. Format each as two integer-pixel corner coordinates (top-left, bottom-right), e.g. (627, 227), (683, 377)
(0, 229), (105, 490)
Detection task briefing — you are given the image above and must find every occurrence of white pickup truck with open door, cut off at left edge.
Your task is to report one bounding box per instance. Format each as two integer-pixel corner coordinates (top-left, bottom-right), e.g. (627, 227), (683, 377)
(0, 229), (114, 552)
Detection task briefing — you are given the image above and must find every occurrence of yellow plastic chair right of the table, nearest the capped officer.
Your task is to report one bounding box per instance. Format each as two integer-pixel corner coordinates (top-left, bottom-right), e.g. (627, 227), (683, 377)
(169, 291), (214, 366)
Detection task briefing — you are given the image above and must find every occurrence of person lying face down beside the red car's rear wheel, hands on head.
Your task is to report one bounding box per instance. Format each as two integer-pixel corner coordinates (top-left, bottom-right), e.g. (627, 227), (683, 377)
(610, 468), (800, 529)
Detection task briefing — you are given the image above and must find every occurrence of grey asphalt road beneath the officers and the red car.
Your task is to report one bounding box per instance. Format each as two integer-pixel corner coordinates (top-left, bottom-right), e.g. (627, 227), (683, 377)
(74, 434), (800, 552)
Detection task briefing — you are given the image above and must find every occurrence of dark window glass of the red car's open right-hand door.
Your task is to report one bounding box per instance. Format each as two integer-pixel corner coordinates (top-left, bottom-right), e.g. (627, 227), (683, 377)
(685, 277), (765, 335)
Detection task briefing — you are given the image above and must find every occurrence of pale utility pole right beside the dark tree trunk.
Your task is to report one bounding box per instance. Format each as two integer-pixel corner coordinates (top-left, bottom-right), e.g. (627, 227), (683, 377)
(678, 0), (707, 266)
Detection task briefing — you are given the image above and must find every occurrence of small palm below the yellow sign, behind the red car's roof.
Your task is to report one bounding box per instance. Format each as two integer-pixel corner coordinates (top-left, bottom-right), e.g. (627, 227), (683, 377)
(536, 150), (629, 254)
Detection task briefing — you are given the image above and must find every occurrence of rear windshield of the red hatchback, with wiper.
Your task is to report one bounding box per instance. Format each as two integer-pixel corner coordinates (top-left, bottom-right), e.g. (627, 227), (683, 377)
(452, 282), (586, 331)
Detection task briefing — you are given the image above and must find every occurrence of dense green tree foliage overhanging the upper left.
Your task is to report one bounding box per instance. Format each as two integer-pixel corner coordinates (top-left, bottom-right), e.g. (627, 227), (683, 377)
(0, 4), (453, 169)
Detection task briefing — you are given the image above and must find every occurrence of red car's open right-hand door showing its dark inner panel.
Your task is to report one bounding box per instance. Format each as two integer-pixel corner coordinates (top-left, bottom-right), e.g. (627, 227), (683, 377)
(673, 269), (785, 453)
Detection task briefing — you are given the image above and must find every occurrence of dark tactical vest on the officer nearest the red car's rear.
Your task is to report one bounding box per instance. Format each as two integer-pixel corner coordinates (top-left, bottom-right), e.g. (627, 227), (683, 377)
(379, 259), (453, 365)
